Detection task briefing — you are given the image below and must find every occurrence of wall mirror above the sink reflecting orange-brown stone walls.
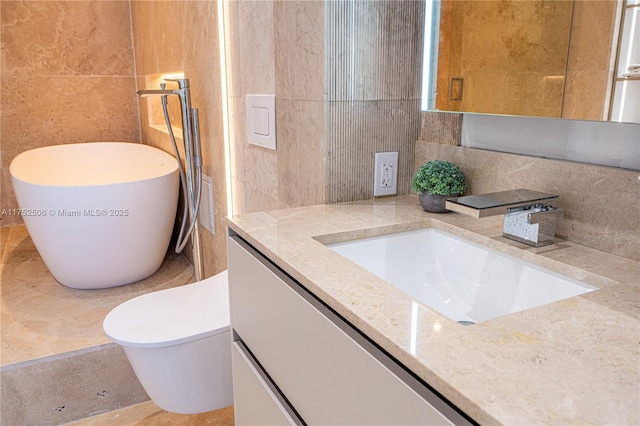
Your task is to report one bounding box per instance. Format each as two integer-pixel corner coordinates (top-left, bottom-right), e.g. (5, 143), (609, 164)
(423, 0), (640, 123)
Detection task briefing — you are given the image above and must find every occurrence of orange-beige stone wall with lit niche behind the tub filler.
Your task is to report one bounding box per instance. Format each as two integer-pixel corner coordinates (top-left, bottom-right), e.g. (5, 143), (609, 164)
(131, 0), (227, 276)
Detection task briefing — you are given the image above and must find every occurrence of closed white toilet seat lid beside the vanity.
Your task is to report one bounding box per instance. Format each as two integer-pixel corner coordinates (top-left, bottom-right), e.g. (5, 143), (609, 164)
(103, 270), (230, 348)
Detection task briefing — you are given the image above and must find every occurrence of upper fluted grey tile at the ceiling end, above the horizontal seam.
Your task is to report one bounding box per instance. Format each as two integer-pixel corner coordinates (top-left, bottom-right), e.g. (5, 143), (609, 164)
(325, 0), (424, 101)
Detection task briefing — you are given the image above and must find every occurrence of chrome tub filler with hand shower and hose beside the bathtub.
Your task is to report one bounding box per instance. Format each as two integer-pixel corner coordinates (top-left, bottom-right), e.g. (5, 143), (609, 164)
(138, 78), (204, 281)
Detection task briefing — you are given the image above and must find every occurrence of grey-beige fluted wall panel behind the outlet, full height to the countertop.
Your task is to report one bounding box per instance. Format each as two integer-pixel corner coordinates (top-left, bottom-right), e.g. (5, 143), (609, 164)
(325, 0), (424, 203)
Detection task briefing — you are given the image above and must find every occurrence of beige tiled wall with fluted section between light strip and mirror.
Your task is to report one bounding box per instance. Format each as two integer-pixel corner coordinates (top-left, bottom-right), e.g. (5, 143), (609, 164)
(227, 0), (423, 213)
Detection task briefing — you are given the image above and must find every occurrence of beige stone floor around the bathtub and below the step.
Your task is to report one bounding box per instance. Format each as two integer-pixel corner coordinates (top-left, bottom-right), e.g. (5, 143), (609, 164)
(0, 225), (233, 425)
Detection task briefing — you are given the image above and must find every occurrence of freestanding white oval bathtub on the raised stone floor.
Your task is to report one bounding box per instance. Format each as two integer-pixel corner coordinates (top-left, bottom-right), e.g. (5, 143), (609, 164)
(10, 142), (180, 289)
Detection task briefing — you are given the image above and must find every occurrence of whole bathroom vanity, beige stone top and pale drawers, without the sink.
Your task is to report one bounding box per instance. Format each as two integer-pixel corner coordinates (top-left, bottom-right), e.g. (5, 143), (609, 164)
(228, 196), (640, 424)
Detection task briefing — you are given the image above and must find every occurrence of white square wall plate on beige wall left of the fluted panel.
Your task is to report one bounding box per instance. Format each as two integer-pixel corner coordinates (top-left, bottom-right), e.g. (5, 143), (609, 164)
(247, 95), (276, 149)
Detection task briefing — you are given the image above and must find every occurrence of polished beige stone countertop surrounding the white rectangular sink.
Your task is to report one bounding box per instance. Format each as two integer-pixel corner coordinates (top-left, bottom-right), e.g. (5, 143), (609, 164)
(228, 196), (640, 425)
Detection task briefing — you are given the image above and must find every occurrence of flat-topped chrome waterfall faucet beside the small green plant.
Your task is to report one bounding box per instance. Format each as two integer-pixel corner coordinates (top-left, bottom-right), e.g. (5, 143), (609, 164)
(446, 189), (563, 247)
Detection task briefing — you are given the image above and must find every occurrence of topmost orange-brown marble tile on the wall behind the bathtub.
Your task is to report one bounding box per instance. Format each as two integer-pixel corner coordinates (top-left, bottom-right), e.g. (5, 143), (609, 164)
(2, 0), (133, 76)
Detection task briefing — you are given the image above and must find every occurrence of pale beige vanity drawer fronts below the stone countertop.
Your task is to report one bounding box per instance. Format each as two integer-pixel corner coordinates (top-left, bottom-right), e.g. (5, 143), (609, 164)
(228, 235), (469, 425)
